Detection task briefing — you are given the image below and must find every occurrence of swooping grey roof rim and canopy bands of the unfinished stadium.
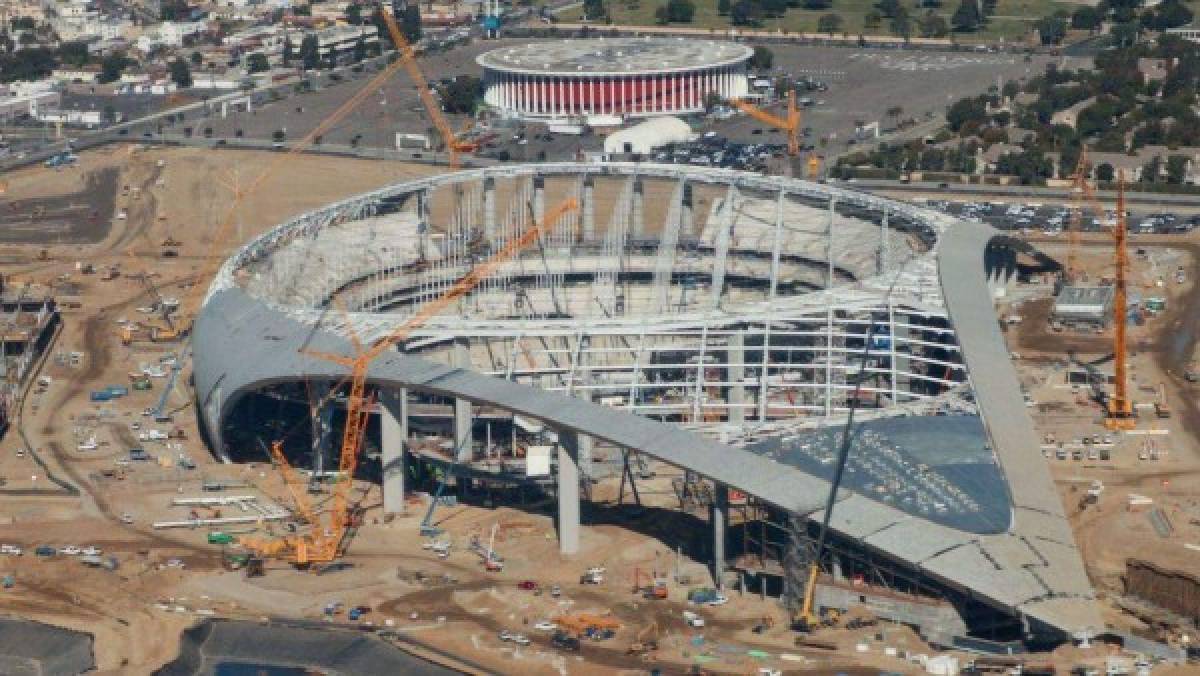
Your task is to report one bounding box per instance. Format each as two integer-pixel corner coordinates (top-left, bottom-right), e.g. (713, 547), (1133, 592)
(193, 163), (1103, 634)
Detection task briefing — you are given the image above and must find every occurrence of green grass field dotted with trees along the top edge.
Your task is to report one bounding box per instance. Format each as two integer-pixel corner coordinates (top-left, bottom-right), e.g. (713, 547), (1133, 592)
(558, 0), (1080, 42)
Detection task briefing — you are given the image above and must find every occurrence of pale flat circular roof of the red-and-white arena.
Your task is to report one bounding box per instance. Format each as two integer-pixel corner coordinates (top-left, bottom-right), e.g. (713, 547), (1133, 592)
(475, 37), (754, 76)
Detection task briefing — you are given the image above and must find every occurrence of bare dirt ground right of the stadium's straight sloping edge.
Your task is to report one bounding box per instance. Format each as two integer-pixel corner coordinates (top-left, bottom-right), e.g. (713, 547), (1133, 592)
(1009, 235), (1200, 639)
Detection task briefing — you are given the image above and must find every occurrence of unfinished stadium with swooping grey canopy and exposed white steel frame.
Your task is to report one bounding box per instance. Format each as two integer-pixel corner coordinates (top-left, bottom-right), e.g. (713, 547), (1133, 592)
(193, 163), (1102, 642)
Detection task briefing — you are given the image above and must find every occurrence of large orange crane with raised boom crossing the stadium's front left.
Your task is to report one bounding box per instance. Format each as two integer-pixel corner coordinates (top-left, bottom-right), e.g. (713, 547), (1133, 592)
(241, 198), (580, 566)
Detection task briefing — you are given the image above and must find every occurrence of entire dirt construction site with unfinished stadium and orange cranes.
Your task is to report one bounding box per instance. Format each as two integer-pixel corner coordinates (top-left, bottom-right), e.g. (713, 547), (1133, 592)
(0, 13), (1200, 675)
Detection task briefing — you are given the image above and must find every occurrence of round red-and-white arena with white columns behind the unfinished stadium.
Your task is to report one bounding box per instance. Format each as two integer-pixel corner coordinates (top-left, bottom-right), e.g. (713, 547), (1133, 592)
(476, 37), (754, 118)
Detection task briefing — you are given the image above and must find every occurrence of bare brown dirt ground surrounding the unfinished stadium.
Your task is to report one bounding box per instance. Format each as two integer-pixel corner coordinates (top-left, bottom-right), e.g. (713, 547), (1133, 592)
(0, 145), (1185, 674)
